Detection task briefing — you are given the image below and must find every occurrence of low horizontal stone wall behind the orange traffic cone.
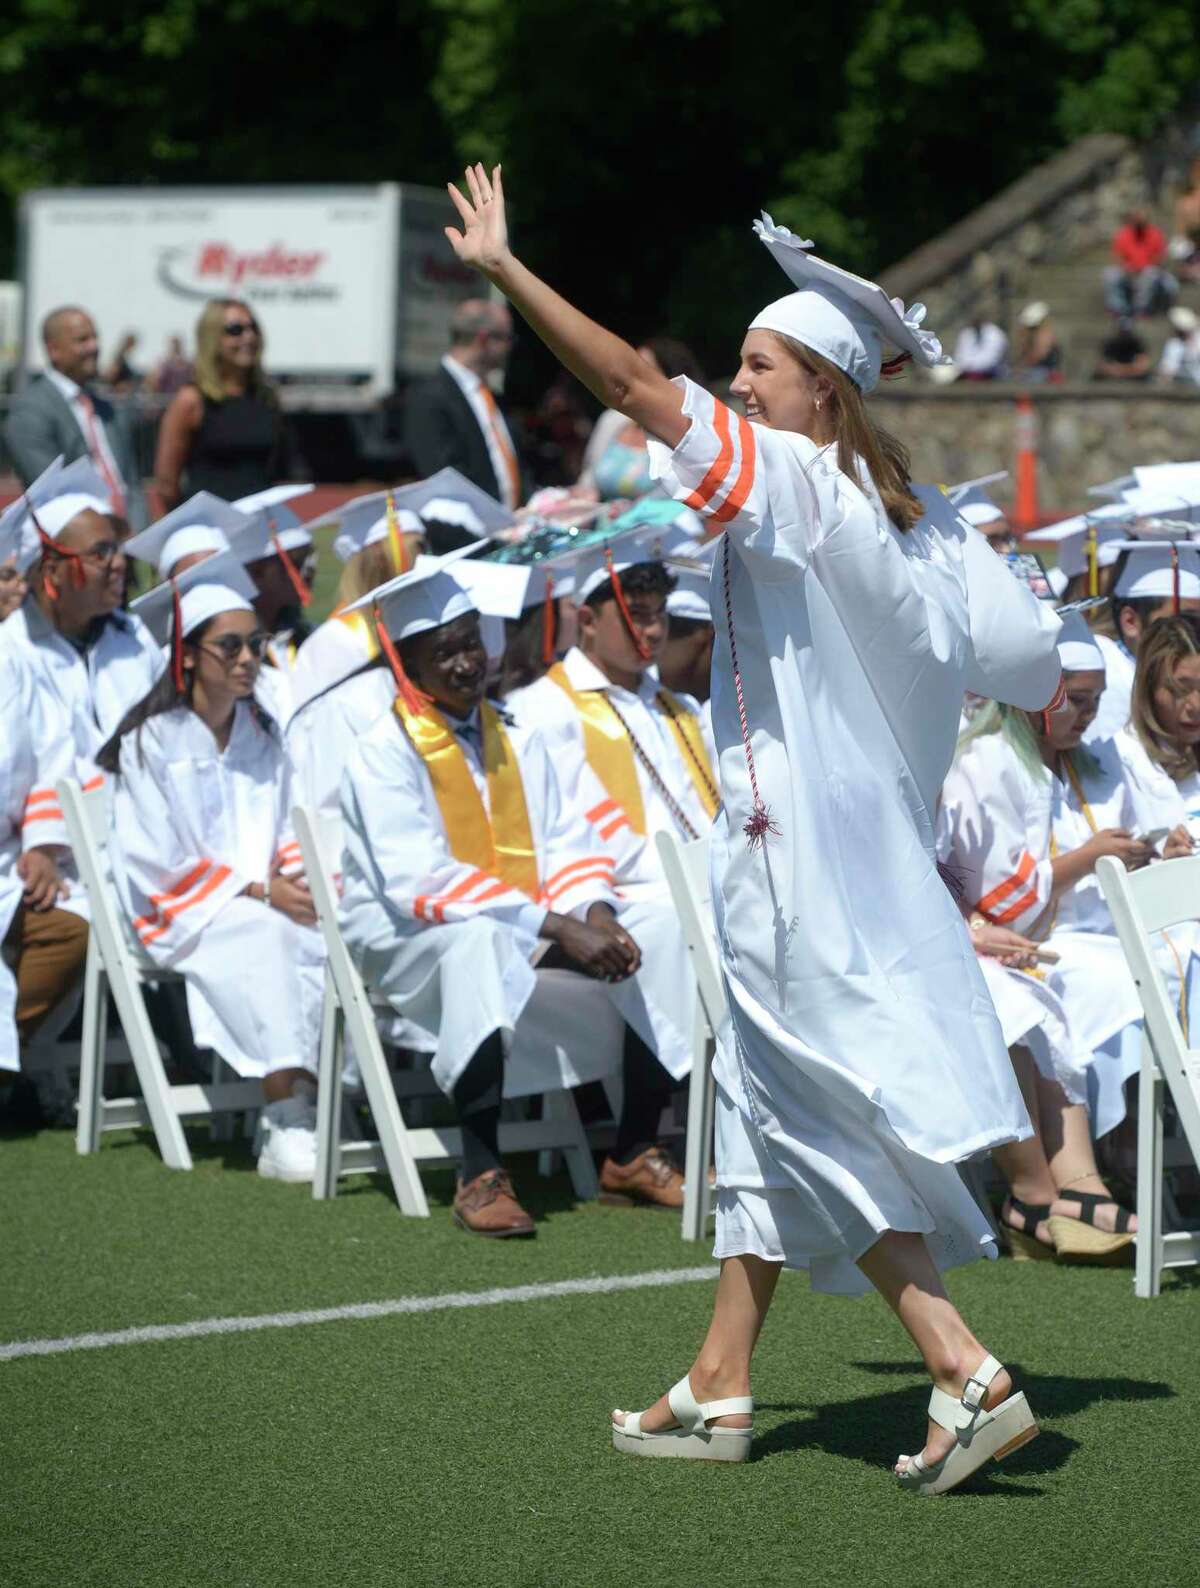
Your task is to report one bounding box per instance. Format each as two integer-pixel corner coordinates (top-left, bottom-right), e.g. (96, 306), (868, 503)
(868, 383), (1200, 516)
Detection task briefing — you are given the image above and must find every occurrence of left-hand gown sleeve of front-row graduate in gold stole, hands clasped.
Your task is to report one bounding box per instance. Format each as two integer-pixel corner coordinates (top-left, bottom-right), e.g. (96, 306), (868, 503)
(341, 724), (546, 937)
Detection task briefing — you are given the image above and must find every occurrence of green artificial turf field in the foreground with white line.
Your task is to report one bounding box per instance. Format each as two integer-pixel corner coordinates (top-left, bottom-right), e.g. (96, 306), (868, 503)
(0, 1132), (1200, 1588)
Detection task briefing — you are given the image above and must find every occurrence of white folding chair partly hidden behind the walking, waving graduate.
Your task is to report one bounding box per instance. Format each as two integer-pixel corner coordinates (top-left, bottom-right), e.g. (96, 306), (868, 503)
(657, 832), (727, 1240)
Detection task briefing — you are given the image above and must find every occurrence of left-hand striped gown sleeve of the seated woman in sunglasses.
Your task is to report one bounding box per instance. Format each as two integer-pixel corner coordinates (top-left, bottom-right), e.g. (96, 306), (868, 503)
(113, 726), (250, 962)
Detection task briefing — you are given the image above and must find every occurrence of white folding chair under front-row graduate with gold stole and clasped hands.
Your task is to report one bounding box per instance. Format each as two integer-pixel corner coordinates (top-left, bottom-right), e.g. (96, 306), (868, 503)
(292, 807), (600, 1218)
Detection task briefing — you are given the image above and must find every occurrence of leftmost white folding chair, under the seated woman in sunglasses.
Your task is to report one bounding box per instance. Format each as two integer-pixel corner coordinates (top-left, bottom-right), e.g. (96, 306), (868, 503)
(59, 778), (262, 1169)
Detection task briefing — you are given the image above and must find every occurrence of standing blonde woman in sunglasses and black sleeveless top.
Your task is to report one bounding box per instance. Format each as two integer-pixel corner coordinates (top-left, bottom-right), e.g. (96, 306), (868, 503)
(154, 299), (290, 513)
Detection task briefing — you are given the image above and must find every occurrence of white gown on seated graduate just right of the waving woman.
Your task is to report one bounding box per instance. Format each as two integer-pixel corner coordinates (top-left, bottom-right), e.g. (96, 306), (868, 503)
(944, 734), (1194, 1135)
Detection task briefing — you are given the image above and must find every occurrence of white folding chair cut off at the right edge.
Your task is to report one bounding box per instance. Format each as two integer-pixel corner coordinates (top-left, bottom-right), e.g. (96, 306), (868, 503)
(1095, 854), (1200, 1297)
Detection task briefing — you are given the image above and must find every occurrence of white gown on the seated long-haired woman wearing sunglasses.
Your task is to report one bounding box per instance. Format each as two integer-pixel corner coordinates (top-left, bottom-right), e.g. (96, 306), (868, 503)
(113, 702), (324, 1077)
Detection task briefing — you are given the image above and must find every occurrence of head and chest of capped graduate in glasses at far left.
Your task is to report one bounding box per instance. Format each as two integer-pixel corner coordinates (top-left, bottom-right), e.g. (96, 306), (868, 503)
(0, 457), (163, 787)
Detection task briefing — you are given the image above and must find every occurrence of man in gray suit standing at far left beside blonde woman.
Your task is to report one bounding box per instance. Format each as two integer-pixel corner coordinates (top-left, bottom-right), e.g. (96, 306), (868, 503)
(5, 305), (144, 529)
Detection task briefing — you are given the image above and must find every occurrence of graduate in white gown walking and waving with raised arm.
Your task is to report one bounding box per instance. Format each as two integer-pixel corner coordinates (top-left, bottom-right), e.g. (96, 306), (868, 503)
(448, 167), (1059, 1493)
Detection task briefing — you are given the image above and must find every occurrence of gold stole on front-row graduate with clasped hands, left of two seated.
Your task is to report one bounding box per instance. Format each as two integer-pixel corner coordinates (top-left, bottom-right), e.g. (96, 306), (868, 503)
(392, 699), (541, 899)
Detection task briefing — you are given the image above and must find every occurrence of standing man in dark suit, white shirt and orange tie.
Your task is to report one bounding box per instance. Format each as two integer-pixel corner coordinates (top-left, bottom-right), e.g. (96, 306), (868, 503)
(405, 299), (525, 508)
